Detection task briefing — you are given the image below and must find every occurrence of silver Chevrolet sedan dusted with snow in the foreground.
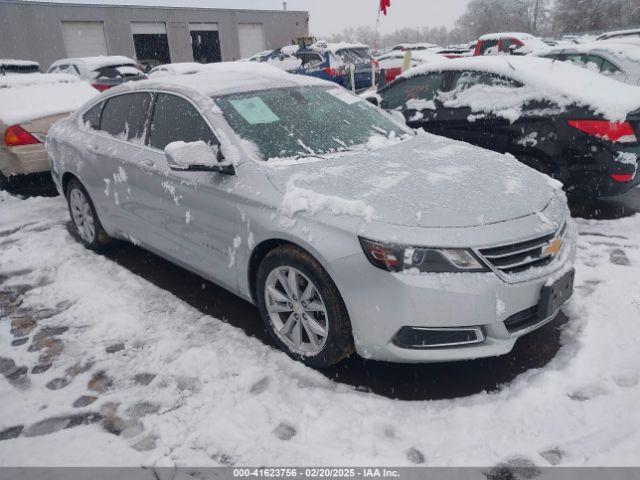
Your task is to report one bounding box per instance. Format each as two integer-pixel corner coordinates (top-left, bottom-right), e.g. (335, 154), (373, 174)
(47, 63), (576, 367)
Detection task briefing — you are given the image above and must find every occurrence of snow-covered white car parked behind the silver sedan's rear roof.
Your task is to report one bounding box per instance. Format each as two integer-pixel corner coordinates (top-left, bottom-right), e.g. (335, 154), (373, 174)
(47, 55), (146, 92)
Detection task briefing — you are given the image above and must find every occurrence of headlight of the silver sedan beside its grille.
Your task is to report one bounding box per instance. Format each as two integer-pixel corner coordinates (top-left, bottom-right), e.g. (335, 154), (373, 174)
(360, 237), (489, 273)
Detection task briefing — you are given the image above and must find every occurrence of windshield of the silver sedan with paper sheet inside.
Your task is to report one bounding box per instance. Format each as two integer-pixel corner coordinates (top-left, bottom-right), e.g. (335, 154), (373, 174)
(216, 87), (408, 160)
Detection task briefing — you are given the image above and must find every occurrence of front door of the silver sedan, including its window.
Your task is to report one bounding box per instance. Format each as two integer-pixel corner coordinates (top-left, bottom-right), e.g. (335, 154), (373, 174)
(143, 93), (238, 290)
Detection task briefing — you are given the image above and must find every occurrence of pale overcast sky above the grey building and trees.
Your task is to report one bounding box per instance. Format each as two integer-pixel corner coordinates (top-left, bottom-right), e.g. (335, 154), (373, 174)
(35, 0), (470, 36)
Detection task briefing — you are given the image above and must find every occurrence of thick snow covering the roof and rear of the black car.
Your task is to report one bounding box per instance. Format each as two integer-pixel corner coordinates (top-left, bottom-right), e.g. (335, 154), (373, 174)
(402, 56), (640, 121)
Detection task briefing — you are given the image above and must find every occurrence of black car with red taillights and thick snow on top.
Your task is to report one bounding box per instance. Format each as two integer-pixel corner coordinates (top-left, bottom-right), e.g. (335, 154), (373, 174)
(371, 57), (640, 197)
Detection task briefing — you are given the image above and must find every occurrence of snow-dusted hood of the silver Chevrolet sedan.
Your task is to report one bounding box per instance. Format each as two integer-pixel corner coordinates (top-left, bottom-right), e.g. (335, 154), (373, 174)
(268, 133), (554, 228)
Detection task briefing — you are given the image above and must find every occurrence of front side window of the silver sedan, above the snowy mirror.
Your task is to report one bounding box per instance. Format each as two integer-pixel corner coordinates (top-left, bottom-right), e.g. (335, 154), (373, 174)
(149, 93), (219, 150)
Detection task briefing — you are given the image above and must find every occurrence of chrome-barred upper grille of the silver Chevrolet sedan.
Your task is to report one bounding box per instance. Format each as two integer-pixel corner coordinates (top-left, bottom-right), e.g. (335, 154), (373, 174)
(479, 224), (566, 275)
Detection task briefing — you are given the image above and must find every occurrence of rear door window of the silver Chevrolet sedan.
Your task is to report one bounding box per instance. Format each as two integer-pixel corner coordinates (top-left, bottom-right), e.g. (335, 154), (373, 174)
(100, 92), (152, 142)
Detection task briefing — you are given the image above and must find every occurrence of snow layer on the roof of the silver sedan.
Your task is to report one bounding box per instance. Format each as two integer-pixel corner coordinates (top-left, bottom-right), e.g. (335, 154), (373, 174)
(112, 62), (335, 97)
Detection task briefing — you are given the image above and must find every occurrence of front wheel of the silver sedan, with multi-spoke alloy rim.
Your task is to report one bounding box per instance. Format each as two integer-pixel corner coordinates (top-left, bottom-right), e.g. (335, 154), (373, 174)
(256, 245), (355, 368)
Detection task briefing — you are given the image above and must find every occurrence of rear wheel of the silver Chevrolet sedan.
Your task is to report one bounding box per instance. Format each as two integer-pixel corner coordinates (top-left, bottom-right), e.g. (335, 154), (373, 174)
(65, 179), (111, 250)
